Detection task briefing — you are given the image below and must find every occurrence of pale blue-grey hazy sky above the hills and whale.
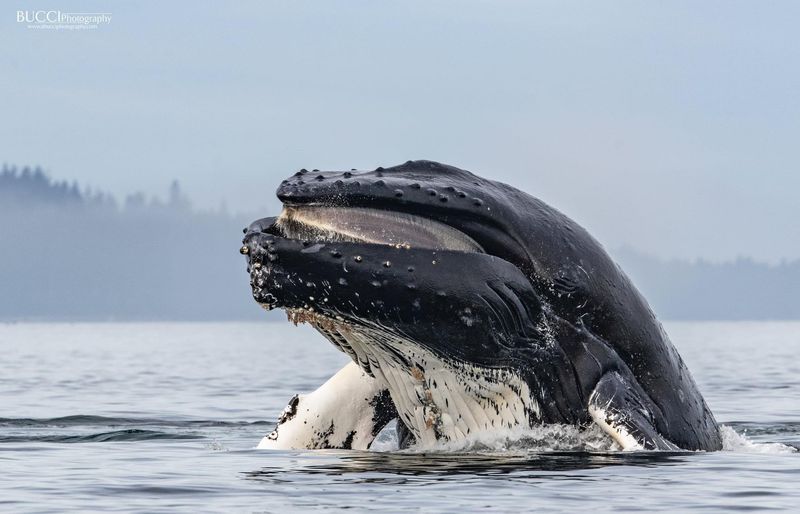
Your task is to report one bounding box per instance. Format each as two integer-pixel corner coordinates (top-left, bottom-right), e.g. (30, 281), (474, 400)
(0, 0), (800, 261)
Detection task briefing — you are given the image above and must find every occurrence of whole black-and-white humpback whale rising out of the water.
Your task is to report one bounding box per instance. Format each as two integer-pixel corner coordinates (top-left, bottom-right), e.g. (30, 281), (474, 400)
(240, 161), (722, 450)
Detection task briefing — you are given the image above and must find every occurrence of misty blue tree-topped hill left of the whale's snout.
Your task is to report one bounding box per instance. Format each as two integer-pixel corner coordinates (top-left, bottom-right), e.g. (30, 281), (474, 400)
(0, 166), (265, 320)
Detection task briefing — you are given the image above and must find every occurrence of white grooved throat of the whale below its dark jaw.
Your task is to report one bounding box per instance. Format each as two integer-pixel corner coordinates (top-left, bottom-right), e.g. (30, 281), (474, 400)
(311, 312), (541, 448)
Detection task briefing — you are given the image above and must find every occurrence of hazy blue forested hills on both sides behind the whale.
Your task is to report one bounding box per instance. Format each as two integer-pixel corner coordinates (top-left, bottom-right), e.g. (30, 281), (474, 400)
(0, 166), (800, 320)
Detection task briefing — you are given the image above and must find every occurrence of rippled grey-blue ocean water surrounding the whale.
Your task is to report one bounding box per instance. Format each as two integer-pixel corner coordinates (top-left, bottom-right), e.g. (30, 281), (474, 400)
(0, 322), (800, 513)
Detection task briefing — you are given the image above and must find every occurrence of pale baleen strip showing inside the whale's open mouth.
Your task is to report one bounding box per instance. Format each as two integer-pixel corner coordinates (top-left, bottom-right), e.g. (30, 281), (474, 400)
(275, 205), (485, 253)
